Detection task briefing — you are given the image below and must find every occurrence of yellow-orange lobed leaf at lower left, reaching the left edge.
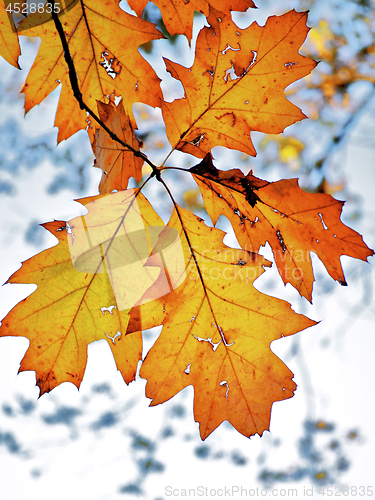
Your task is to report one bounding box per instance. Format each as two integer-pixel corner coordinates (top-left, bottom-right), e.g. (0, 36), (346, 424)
(0, 190), (164, 395)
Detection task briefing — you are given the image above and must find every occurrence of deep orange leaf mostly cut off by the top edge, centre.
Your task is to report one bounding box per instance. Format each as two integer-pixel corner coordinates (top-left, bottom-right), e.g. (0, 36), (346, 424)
(128, 0), (256, 41)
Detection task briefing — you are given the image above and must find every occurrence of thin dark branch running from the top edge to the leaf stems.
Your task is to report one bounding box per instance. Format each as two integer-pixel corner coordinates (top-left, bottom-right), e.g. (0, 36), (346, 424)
(50, 0), (161, 181)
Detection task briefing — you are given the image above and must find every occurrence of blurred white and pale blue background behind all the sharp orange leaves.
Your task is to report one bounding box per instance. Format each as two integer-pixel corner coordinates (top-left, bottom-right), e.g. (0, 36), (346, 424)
(0, 0), (375, 500)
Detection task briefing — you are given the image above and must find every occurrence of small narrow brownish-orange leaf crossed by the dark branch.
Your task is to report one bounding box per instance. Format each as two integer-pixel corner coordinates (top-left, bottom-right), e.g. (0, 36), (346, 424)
(91, 101), (143, 193)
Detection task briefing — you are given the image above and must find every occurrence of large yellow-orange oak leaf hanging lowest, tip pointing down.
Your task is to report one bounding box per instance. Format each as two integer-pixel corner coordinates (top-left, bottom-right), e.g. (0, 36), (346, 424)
(140, 206), (315, 439)
